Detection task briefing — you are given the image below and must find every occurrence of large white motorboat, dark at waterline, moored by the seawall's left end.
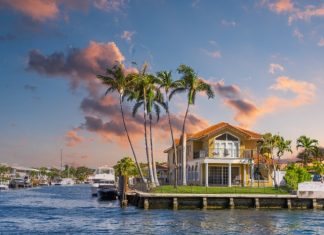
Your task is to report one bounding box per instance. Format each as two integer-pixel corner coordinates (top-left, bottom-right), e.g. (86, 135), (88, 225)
(91, 166), (118, 199)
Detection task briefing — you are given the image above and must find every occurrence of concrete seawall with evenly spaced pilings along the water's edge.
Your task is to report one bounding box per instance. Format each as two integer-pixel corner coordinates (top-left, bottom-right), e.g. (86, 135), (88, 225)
(127, 192), (324, 210)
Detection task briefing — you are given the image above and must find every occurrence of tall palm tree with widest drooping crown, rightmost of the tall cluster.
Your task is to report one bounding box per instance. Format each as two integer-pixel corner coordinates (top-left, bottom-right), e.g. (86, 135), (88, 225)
(169, 64), (214, 185)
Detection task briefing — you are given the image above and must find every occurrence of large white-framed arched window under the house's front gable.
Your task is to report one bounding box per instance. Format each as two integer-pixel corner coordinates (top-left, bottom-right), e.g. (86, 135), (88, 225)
(214, 133), (240, 158)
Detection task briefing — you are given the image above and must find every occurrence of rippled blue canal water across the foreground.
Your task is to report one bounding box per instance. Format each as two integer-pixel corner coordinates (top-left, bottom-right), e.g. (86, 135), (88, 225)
(0, 185), (324, 235)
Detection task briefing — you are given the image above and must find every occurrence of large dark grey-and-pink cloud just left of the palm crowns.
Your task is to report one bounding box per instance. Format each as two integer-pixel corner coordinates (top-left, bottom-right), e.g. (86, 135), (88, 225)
(27, 41), (125, 95)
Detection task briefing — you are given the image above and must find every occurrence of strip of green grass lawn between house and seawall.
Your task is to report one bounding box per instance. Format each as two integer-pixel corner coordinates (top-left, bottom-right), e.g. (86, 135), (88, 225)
(151, 185), (289, 194)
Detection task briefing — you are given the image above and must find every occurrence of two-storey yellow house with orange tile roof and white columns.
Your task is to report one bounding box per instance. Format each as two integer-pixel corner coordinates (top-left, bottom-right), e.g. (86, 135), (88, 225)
(164, 122), (273, 187)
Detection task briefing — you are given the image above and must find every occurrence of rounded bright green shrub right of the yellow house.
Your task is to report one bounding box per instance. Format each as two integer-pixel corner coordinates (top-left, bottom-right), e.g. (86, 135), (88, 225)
(285, 164), (312, 189)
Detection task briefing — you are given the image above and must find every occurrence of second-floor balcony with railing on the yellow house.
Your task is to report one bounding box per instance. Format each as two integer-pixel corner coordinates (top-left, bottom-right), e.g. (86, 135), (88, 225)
(193, 148), (257, 159)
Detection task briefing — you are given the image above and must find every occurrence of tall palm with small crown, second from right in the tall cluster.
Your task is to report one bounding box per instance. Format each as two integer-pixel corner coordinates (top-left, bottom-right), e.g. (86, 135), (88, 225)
(157, 71), (181, 188)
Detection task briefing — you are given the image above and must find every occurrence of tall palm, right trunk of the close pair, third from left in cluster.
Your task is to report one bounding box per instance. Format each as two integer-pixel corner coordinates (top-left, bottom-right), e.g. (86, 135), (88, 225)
(133, 73), (165, 186)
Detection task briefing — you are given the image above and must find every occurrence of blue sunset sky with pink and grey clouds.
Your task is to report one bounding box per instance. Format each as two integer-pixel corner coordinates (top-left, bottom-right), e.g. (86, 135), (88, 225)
(0, 0), (324, 167)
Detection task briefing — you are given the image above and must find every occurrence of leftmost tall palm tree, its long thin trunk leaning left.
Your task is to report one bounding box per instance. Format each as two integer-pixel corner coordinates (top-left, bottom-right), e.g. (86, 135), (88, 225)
(97, 64), (145, 182)
